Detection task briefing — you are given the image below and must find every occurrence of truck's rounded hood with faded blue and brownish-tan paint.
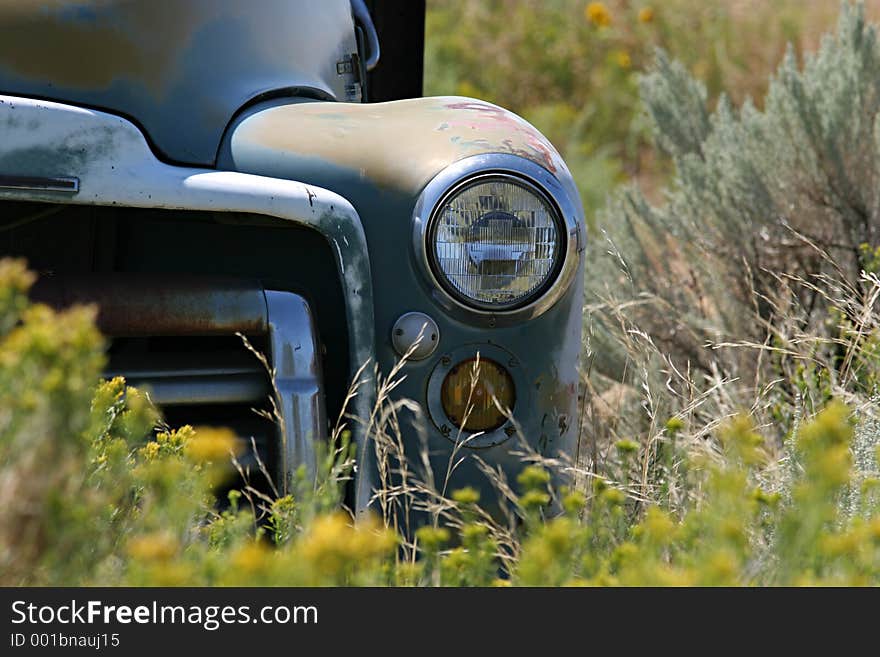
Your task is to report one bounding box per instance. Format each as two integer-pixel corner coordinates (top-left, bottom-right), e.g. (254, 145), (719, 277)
(0, 0), (357, 166)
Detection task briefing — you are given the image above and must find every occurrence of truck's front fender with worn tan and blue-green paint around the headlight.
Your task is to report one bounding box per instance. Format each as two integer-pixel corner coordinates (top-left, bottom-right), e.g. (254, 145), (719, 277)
(218, 97), (584, 496)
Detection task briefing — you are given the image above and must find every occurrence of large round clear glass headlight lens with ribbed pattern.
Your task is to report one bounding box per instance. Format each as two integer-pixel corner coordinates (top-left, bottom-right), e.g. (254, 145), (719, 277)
(427, 175), (564, 310)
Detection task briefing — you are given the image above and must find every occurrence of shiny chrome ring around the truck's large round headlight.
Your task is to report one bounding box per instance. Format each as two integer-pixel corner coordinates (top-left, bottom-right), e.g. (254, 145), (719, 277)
(413, 153), (583, 326)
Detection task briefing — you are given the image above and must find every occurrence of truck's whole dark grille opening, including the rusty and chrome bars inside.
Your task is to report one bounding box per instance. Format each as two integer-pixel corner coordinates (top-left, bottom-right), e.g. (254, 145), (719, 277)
(0, 201), (349, 488)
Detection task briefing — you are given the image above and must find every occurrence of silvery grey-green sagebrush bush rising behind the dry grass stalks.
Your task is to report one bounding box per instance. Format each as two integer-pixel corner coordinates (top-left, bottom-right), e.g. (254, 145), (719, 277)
(588, 4), (880, 375)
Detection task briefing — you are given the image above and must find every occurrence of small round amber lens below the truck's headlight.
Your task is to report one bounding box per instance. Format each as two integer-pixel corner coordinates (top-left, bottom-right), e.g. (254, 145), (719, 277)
(440, 358), (516, 432)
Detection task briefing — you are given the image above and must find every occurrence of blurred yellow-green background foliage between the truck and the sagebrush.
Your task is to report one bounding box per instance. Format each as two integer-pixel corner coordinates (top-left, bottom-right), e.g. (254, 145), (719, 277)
(425, 0), (880, 223)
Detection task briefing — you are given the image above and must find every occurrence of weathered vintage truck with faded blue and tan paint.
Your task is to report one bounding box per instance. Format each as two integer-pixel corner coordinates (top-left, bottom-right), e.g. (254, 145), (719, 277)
(0, 0), (585, 510)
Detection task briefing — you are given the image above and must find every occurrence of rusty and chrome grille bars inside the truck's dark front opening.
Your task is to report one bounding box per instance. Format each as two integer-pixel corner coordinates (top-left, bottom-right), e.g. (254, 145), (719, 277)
(31, 274), (327, 492)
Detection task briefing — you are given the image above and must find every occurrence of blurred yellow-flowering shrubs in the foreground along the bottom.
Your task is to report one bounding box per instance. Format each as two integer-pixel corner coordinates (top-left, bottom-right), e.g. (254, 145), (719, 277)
(0, 261), (880, 586)
